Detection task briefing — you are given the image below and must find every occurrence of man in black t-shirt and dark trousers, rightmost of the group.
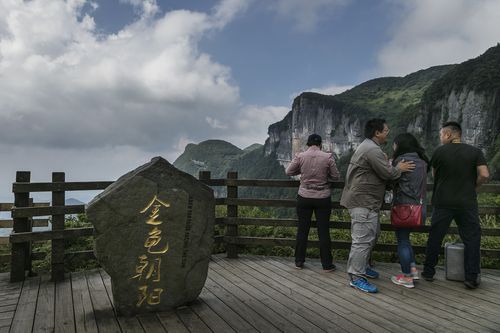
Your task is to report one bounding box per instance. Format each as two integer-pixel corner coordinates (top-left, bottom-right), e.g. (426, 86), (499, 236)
(422, 121), (489, 289)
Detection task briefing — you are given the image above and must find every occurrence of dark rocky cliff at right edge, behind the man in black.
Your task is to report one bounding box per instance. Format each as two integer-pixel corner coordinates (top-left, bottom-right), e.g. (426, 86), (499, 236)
(408, 45), (500, 157)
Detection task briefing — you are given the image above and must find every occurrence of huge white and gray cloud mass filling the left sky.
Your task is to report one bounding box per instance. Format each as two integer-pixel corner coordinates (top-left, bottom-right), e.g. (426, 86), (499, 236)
(0, 0), (279, 201)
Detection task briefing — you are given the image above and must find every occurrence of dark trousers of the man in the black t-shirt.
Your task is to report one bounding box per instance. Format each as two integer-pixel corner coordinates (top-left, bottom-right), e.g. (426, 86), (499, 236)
(424, 207), (481, 281)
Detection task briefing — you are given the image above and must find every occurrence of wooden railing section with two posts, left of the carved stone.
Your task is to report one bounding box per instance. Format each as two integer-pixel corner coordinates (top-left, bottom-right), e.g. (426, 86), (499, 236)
(10, 171), (113, 282)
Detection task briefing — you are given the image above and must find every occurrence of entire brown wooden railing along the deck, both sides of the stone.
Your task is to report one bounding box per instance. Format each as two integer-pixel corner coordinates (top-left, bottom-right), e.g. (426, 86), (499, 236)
(2, 171), (500, 281)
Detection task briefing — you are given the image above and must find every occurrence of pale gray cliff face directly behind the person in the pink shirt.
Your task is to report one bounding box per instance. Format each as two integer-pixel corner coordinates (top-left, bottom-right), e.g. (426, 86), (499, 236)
(265, 93), (369, 167)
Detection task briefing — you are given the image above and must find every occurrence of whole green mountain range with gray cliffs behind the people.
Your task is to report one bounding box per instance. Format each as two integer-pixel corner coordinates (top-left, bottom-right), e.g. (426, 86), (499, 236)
(174, 44), (500, 179)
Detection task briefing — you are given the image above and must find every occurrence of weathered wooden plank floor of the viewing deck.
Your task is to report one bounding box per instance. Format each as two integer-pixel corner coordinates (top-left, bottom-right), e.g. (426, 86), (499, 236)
(0, 255), (500, 333)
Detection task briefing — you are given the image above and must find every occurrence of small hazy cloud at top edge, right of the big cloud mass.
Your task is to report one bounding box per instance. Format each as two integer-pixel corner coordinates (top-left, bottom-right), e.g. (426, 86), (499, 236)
(269, 0), (350, 32)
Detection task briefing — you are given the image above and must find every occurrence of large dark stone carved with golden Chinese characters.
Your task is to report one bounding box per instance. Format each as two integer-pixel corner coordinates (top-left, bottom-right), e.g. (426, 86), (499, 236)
(87, 157), (215, 315)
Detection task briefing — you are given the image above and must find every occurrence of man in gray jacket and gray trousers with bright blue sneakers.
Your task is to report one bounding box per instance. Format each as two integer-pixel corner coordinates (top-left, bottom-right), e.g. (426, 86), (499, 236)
(340, 118), (415, 293)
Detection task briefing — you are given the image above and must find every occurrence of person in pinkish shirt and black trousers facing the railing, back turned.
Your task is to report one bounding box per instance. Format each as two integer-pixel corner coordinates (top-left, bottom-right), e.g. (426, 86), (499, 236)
(286, 134), (339, 272)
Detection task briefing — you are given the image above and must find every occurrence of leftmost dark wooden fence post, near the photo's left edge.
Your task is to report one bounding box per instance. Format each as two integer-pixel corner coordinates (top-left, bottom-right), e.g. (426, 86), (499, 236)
(10, 171), (31, 282)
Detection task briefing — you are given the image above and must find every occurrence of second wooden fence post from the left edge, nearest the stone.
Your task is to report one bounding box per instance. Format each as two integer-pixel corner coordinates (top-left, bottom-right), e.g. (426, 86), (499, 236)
(51, 172), (65, 281)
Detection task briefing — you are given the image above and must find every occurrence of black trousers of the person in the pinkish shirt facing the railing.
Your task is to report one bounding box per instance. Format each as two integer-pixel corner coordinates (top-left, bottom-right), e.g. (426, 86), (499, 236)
(295, 195), (333, 268)
